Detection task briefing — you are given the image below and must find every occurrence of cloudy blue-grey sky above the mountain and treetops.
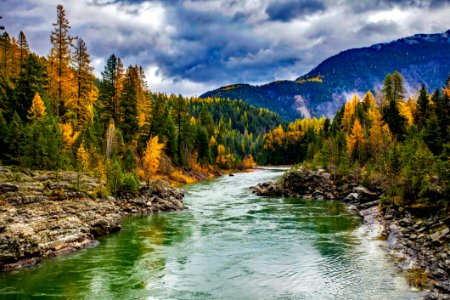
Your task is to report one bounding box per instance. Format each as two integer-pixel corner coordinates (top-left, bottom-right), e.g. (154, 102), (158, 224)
(0, 0), (450, 96)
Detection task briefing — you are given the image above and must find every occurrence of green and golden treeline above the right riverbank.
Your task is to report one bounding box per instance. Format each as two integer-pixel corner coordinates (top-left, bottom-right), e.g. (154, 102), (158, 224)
(264, 72), (450, 215)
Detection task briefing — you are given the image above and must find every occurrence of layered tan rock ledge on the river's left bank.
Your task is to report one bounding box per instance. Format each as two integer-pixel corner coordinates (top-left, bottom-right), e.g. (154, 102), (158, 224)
(0, 167), (185, 271)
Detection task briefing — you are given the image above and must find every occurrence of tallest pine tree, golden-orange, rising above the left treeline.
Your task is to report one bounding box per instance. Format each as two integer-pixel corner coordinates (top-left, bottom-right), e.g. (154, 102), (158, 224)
(47, 5), (75, 117)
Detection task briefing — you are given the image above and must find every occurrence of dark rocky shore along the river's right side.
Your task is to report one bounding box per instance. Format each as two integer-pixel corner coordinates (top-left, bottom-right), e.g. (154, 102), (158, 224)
(252, 167), (450, 299)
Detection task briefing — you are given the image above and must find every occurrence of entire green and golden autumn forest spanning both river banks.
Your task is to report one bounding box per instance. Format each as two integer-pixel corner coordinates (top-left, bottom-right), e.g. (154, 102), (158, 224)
(0, 5), (450, 210)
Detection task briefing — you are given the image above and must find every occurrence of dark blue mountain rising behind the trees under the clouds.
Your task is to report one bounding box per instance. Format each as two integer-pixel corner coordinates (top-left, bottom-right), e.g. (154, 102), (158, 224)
(200, 30), (450, 120)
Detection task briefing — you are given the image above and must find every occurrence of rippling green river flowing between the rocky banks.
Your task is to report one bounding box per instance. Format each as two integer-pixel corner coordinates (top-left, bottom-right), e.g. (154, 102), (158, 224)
(0, 169), (420, 300)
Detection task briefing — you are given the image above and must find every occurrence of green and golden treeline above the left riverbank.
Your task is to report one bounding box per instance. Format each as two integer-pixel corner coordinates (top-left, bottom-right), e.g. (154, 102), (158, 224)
(0, 5), (281, 194)
